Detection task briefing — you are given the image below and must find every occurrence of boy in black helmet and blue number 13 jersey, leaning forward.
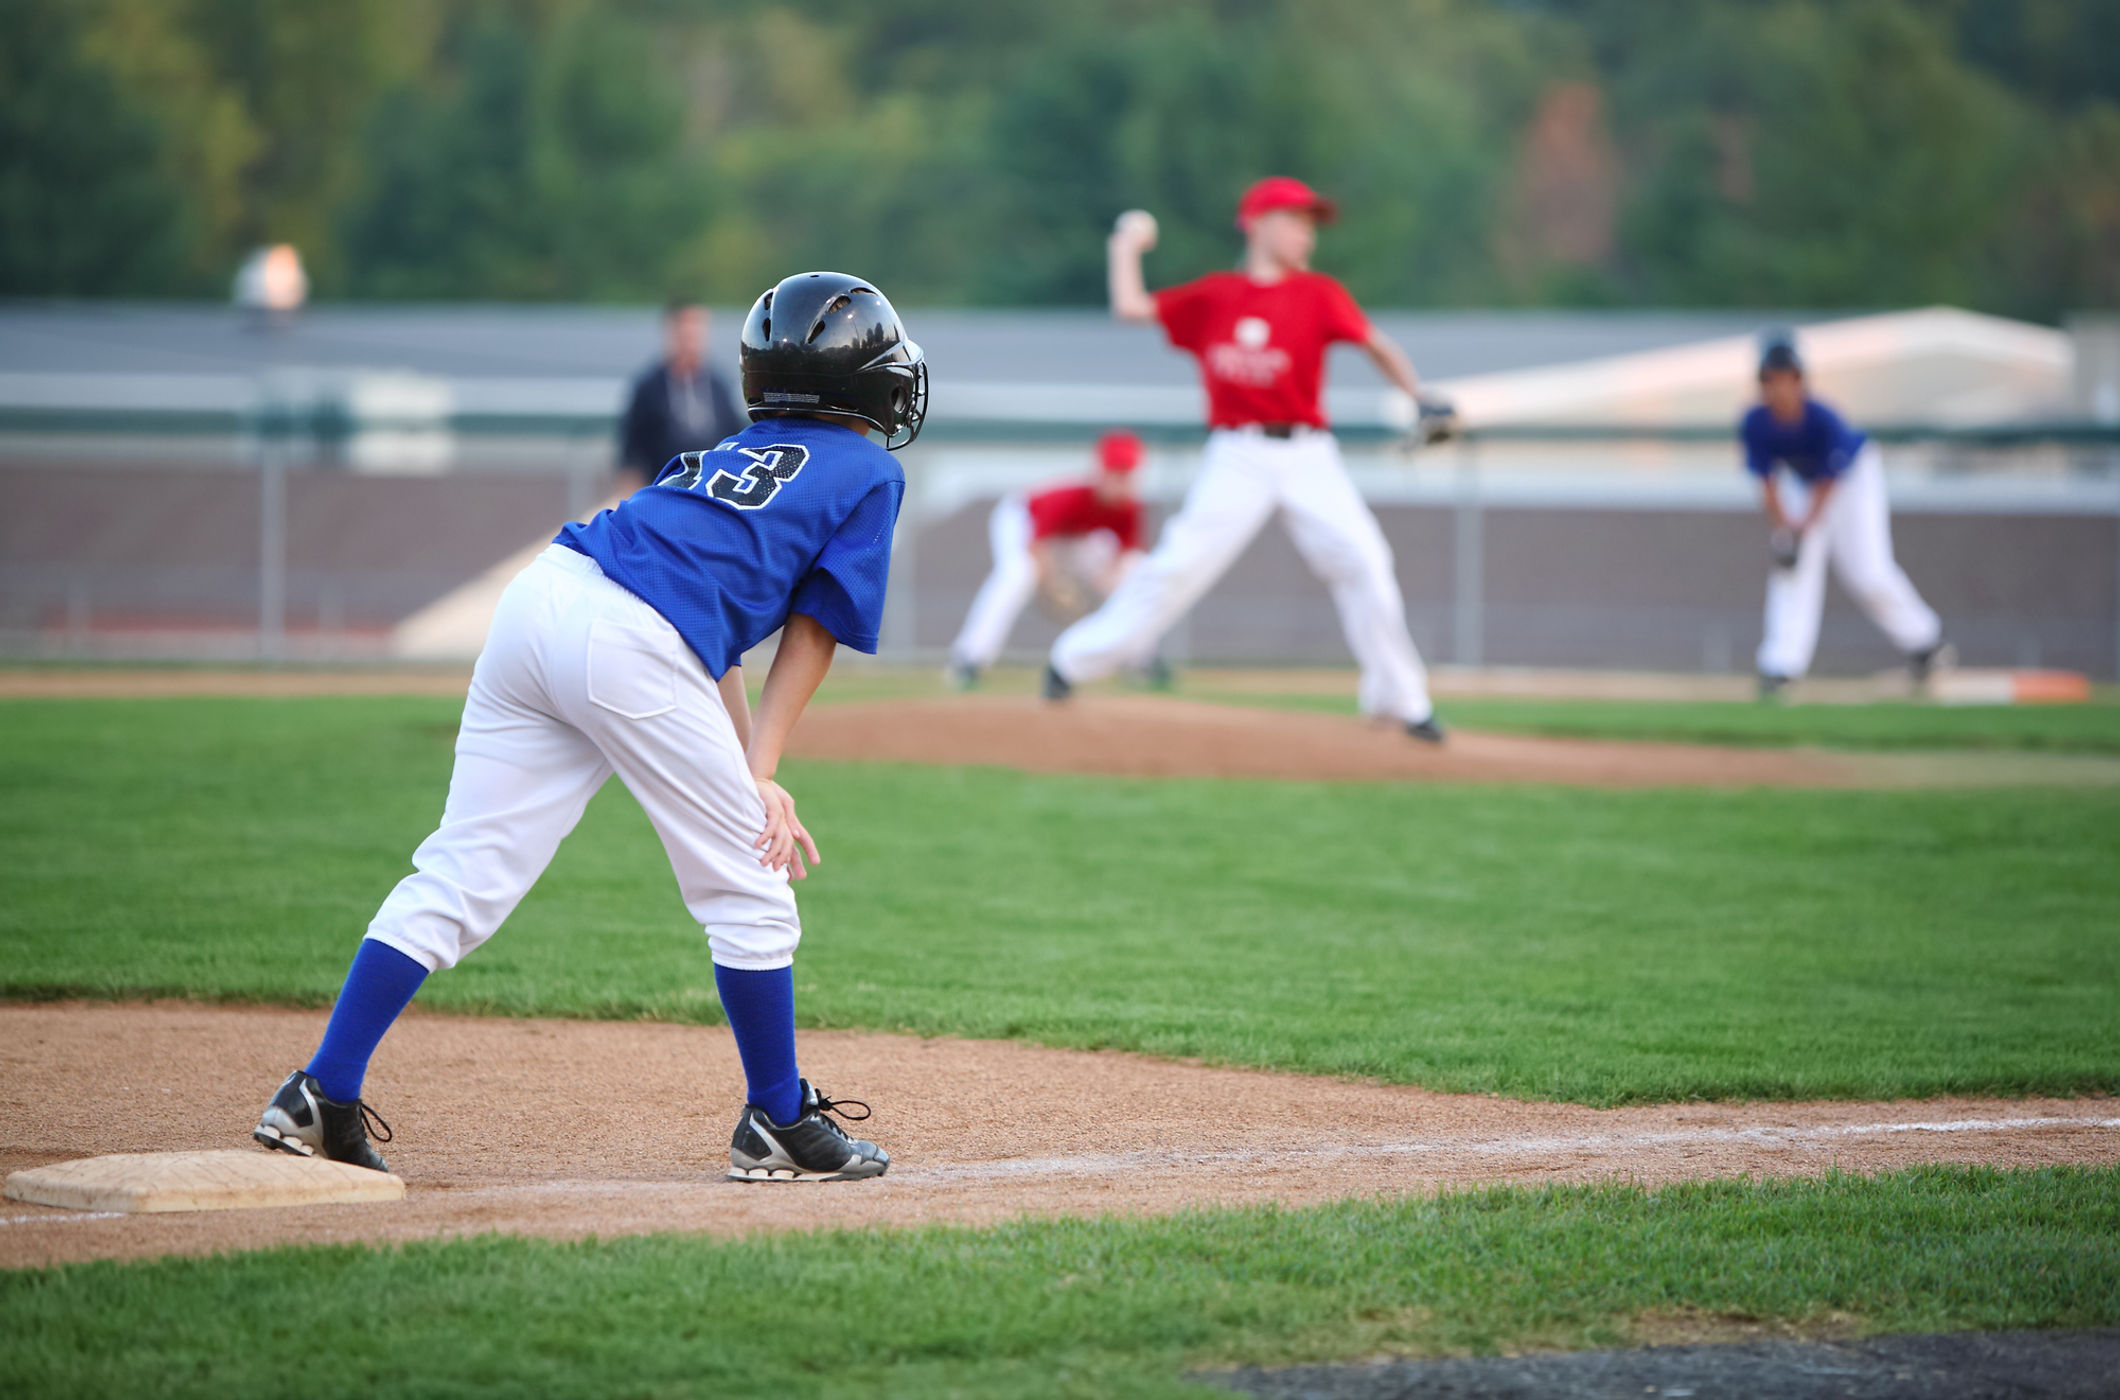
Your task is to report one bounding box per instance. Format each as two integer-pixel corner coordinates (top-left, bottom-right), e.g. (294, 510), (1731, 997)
(254, 272), (926, 1182)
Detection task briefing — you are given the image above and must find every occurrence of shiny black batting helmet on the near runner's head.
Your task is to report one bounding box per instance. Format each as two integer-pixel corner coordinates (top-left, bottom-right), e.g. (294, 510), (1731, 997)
(738, 272), (926, 452)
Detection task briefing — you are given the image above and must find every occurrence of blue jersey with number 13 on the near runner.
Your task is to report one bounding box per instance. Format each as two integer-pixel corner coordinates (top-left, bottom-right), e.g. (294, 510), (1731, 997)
(555, 418), (905, 681)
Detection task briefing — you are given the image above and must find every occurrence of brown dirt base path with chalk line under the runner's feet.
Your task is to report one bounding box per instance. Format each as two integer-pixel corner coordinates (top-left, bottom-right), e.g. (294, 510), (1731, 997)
(0, 1003), (2120, 1268)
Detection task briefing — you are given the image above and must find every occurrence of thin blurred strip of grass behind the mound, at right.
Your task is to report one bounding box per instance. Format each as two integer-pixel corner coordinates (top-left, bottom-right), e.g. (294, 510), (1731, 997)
(1238, 692), (2120, 753)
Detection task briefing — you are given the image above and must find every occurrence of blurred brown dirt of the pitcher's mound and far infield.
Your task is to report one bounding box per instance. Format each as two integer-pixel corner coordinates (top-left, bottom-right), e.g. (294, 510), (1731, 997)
(12, 666), (2120, 787)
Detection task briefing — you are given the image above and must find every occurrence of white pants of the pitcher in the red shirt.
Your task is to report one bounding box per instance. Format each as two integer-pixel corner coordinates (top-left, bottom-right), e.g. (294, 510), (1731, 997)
(1052, 428), (1433, 721)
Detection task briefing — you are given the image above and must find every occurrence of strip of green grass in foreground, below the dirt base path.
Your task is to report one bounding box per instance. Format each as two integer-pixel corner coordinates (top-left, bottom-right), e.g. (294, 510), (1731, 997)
(0, 1169), (2120, 1396)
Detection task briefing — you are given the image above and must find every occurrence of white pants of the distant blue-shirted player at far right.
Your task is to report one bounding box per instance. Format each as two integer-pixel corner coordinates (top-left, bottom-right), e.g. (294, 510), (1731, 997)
(1760, 443), (1942, 677)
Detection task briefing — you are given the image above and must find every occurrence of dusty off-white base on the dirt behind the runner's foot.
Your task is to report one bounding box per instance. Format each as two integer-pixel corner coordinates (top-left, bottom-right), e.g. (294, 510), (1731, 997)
(6, 1150), (405, 1211)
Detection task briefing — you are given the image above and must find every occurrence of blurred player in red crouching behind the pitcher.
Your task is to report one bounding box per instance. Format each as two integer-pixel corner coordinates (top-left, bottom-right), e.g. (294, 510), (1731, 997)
(950, 433), (1141, 689)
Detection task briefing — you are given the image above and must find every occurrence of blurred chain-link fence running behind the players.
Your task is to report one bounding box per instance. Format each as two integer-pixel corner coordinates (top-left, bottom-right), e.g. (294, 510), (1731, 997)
(0, 394), (2120, 677)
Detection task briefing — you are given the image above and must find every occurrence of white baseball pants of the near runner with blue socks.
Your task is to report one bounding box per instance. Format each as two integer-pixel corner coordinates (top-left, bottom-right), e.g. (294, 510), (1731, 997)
(369, 545), (801, 972)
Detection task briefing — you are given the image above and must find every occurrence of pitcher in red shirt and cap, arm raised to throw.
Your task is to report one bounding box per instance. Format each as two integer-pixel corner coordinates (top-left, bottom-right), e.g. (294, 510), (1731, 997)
(1045, 176), (1444, 742)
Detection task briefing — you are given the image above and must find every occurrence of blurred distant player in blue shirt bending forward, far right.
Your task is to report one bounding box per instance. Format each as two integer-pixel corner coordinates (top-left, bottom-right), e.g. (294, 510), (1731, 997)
(1738, 337), (1942, 696)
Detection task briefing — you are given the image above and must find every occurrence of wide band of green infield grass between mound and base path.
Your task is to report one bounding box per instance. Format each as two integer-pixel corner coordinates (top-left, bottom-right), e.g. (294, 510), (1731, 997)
(0, 700), (2120, 1103)
